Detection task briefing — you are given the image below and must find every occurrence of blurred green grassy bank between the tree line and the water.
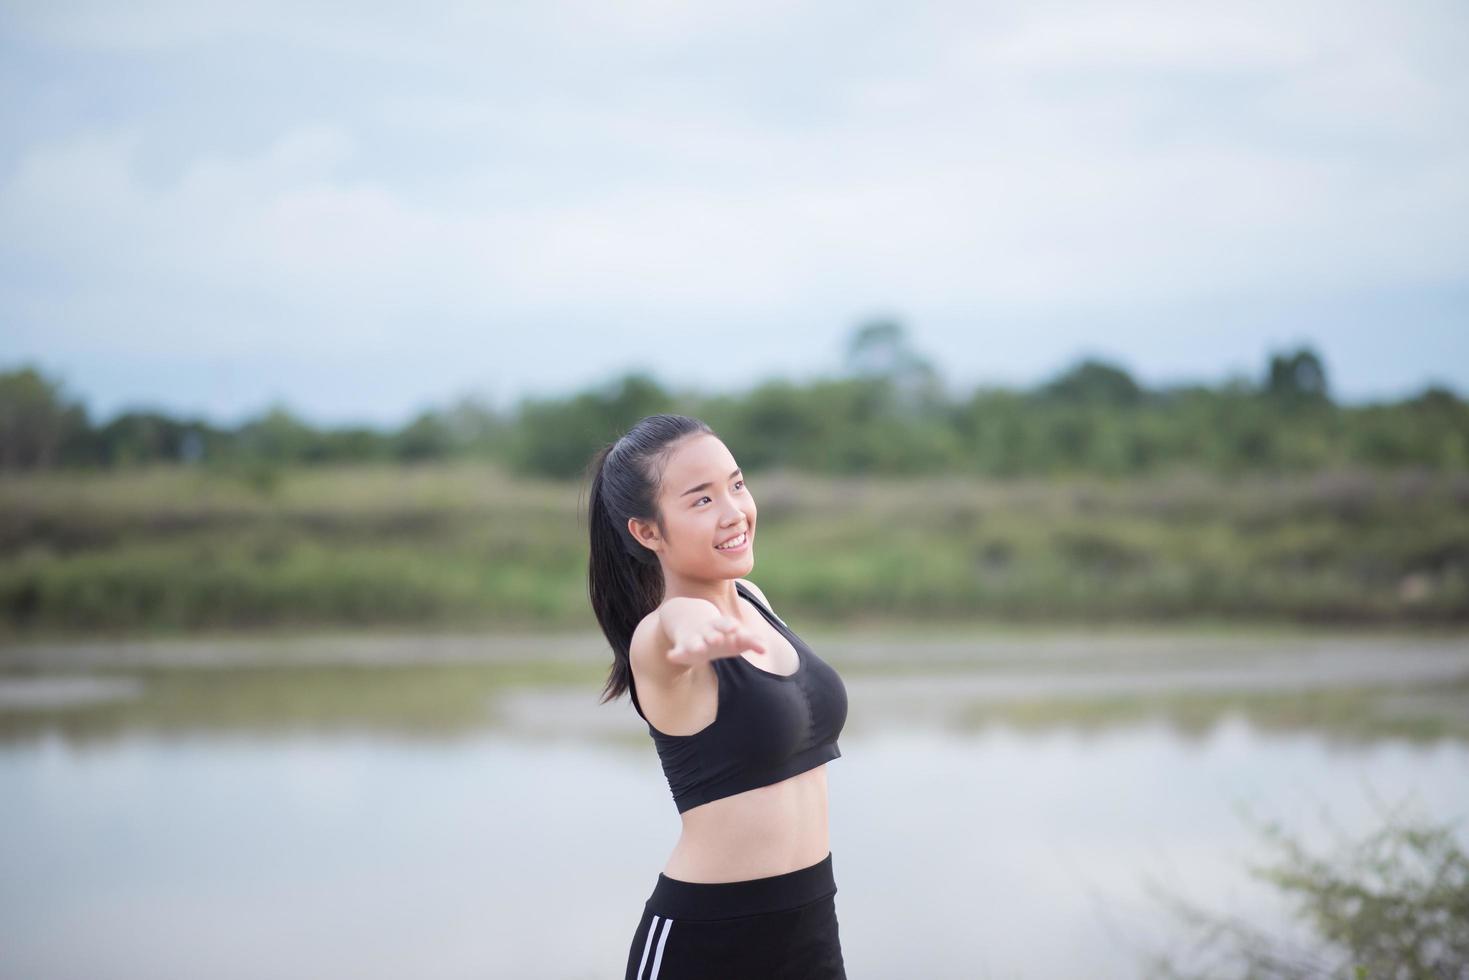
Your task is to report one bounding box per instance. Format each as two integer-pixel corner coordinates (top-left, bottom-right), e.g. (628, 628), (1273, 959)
(0, 461), (1469, 632)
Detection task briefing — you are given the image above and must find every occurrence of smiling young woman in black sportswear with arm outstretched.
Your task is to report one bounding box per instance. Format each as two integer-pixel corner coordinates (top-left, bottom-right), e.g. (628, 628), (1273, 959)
(588, 414), (846, 980)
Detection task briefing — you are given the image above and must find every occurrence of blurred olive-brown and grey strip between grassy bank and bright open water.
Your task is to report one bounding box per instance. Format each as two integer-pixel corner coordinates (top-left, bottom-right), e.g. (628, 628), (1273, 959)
(0, 630), (1469, 745)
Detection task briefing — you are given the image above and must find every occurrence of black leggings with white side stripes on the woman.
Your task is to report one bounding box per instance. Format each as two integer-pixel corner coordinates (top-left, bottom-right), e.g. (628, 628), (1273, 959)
(626, 851), (846, 980)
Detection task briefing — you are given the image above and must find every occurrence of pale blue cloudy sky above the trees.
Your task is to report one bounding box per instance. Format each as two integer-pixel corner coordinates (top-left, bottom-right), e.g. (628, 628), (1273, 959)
(0, 0), (1469, 425)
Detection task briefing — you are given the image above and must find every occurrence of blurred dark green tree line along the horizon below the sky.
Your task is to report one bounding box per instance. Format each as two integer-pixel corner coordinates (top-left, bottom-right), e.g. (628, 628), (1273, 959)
(0, 320), (1469, 479)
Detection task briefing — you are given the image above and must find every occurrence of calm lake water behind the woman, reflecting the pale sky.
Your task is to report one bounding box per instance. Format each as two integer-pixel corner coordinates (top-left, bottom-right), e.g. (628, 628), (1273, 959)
(0, 639), (1469, 980)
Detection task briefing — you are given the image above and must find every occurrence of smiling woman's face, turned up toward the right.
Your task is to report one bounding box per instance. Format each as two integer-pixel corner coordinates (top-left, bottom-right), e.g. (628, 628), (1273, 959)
(629, 432), (755, 580)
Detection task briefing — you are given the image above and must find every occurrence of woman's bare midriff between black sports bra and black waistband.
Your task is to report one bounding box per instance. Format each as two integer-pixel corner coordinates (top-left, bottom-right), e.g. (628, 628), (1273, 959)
(663, 764), (830, 882)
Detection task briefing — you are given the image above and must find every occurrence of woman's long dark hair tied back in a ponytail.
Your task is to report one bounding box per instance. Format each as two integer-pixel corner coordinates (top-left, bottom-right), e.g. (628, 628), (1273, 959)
(586, 414), (714, 704)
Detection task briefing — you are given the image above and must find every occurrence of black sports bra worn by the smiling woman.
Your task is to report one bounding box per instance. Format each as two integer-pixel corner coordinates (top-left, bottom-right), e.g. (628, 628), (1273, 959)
(627, 582), (846, 814)
